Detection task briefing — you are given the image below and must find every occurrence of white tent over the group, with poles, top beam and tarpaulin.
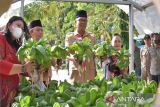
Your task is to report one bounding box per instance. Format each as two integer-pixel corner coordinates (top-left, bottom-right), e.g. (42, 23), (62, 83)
(0, 0), (160, 71)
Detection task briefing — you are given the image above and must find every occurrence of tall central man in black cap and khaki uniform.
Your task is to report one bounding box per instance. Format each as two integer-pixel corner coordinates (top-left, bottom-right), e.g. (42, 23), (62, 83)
(65, 10), (95, 83)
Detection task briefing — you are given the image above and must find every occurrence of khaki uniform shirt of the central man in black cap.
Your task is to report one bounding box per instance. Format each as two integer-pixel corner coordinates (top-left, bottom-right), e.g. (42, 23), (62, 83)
(65, 31), (96, 82)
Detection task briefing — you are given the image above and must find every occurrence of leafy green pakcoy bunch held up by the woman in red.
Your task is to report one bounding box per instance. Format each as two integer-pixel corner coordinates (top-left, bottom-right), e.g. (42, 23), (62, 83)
(17, 39), (52, 68)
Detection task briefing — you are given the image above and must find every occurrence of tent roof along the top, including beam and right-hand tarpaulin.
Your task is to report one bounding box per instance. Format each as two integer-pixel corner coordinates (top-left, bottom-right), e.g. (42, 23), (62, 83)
(0, 0), (160, 34)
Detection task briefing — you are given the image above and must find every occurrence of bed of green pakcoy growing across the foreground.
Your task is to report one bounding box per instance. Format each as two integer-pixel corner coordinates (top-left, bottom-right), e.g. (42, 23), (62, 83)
(12, 73), (157, 107)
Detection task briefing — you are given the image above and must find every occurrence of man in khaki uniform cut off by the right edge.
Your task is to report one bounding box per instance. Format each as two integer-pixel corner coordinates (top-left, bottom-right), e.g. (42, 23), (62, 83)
(146, 33), (160, 84)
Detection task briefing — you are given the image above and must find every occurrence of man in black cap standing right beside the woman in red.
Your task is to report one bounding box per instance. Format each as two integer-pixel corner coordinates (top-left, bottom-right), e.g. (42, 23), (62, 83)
(29, 20), (52, 85)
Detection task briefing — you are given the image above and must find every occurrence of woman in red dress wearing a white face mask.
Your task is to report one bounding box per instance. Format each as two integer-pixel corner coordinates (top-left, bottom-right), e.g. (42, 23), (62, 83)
(0, 16), (34, 107)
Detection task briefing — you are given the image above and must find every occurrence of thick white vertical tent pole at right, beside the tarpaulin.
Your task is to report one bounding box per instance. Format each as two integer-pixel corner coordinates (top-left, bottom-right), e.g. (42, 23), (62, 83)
(129, 4), (134, 73)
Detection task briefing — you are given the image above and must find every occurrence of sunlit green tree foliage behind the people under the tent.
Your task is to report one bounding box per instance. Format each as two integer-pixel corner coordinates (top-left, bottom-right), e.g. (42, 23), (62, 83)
(24, 1), (138, 48)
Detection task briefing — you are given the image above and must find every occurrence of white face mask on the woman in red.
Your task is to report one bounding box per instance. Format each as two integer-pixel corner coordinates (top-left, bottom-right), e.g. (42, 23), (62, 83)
(11, 27), (23, 39)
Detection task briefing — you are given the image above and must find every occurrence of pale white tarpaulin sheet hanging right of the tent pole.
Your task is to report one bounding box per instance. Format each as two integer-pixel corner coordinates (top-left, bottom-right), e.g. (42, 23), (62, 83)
(134, 6), (160, 34)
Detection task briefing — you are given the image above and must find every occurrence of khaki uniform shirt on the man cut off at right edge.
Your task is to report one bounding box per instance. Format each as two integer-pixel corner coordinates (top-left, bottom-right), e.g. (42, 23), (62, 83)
(147, 47), (160, 75)
